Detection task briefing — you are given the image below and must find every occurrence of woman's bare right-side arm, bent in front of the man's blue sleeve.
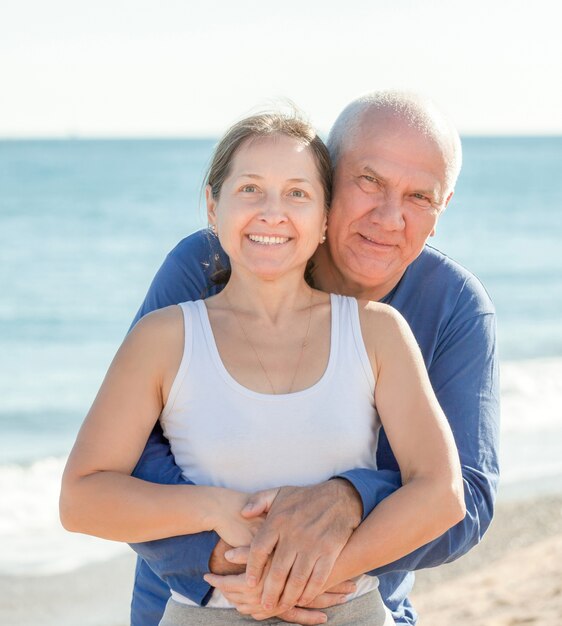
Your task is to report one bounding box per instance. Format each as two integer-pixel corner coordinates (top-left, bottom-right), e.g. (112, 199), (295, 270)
(318, 303), (465, 588)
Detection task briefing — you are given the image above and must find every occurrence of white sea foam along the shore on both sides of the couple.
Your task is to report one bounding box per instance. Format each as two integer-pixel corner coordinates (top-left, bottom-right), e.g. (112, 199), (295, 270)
(0, 359), (562, 575)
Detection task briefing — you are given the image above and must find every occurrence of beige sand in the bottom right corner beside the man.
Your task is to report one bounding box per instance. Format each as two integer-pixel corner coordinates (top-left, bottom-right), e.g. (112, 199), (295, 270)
(412, 497), (562, 626)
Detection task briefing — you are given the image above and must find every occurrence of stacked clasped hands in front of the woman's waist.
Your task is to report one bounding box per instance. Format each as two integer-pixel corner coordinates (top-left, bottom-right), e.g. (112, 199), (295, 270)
(205, 479), (362, 626)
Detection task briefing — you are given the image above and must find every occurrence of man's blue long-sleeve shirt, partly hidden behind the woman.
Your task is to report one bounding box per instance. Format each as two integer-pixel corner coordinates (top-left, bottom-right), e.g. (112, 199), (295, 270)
(131, 231), (499, 626)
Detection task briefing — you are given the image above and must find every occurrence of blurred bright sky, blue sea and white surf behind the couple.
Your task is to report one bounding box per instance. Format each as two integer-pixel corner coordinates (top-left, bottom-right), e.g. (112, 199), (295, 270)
(0, 0), (562, 624)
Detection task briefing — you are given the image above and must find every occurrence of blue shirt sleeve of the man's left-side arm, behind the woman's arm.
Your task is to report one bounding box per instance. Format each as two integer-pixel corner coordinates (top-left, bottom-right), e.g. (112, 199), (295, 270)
(130, 231), (223, 604)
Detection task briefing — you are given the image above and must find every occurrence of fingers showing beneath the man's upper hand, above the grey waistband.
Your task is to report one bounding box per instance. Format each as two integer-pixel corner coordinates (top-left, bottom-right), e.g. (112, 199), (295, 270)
(205, 568), (356, 626)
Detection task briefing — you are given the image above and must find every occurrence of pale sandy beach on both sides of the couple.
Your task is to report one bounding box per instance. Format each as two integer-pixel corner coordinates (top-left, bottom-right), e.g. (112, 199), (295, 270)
(0, 495), (562, 626)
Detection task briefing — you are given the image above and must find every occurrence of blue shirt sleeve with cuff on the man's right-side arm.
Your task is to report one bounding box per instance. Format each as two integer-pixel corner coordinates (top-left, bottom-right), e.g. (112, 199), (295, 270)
(334, 313), (499, 575)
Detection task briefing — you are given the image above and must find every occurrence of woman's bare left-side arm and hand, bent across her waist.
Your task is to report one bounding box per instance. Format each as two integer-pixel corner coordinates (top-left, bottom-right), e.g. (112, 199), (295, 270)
(60, 307), (252, 545)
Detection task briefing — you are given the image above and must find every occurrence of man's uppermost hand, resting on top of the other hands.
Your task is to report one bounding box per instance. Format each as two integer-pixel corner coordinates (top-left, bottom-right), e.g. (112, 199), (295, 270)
(238, 479), (362, 612)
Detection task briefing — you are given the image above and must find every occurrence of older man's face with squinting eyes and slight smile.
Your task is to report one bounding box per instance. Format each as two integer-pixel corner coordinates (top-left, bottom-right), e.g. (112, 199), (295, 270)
(328, 114), (452, 299)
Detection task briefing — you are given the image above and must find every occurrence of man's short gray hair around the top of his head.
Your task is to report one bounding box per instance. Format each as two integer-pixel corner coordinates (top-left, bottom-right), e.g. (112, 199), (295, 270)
(327, 91), (462, 191)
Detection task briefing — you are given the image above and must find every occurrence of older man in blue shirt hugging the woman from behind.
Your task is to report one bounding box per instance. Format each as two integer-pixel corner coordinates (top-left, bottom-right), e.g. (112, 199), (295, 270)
(128, 92), (499, 626)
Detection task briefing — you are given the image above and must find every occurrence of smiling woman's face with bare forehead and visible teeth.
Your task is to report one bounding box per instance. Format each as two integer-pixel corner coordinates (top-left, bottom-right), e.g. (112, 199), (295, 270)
(206, 135), (326, 279)
